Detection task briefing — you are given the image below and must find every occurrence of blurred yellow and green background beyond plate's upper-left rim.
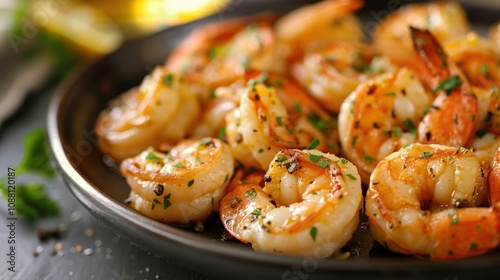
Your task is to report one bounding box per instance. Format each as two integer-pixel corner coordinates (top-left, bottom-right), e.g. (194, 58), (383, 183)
(0, 0), (230, 129)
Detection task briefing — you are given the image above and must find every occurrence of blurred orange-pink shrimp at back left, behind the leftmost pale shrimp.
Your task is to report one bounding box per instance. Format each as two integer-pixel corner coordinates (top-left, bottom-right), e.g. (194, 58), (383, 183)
(166, 15), (284, 94)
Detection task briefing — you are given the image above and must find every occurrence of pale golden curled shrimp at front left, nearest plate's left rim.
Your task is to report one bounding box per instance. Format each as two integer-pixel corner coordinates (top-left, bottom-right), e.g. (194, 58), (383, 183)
(120, 138), (234, 226)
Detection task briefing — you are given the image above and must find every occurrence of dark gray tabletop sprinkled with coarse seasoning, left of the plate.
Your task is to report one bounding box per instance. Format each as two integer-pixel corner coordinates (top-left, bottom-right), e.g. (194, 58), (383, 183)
(0, 84), (214, 280)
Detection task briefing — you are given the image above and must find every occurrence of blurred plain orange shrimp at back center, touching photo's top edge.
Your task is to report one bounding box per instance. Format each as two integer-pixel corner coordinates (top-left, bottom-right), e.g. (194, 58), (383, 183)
(276, 0), (363, 60)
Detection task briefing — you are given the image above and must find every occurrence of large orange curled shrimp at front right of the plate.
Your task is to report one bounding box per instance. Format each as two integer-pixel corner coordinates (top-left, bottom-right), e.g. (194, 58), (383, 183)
(366, 144), (500, 260)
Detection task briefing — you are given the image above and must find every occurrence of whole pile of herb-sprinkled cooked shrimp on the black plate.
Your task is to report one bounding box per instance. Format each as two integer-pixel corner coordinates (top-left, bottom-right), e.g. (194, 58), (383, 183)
(95, 0), (500, 260)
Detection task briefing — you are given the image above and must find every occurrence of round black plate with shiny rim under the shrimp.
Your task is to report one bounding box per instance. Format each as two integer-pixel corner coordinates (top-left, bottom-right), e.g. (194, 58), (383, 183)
(48, 0), (500, 280)
